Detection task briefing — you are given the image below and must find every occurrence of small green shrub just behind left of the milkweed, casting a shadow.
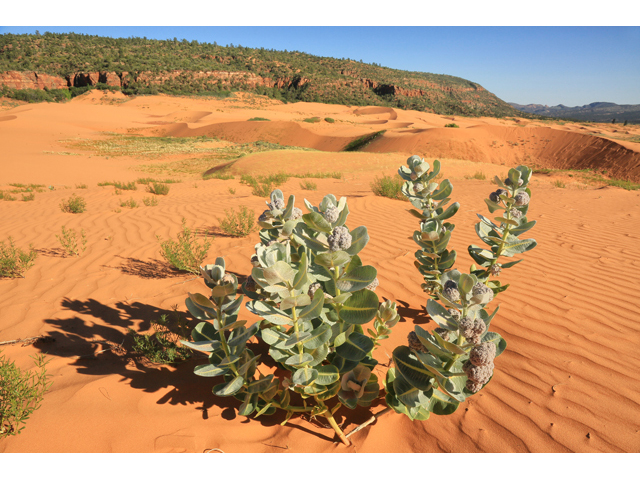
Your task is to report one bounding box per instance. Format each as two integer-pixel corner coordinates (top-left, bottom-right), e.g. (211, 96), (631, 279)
(157, 218), (212, 275)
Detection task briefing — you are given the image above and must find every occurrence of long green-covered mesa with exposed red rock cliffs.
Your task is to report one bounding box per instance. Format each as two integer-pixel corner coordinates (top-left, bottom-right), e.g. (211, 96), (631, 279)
(0, 32), (522, 117)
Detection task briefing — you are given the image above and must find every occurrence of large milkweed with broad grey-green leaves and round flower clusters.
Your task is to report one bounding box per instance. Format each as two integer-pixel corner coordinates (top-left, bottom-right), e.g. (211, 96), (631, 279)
(182, 155), (536, 445)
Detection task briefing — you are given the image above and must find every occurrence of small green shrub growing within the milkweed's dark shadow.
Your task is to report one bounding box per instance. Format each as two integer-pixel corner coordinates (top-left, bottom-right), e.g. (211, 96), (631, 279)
(128, 311), (192, 364)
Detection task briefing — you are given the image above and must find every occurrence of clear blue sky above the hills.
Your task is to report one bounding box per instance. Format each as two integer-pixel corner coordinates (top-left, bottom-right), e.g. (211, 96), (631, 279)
(0, 26), (640, 106)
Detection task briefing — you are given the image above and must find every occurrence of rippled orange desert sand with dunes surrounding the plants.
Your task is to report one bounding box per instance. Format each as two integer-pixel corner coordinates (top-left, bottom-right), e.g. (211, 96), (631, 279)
(0, 91), (640, 453)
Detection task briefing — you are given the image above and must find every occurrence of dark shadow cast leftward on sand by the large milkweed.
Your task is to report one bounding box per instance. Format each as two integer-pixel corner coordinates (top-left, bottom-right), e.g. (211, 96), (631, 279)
(34, 298), (379, 441)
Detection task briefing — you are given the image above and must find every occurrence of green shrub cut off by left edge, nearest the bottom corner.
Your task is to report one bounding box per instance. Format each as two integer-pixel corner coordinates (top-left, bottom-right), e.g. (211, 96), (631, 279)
(0, 348), (51, 439)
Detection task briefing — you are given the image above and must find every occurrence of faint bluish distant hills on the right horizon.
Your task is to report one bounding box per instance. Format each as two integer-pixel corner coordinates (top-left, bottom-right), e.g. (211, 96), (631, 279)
(509, 102), (640, 123)
